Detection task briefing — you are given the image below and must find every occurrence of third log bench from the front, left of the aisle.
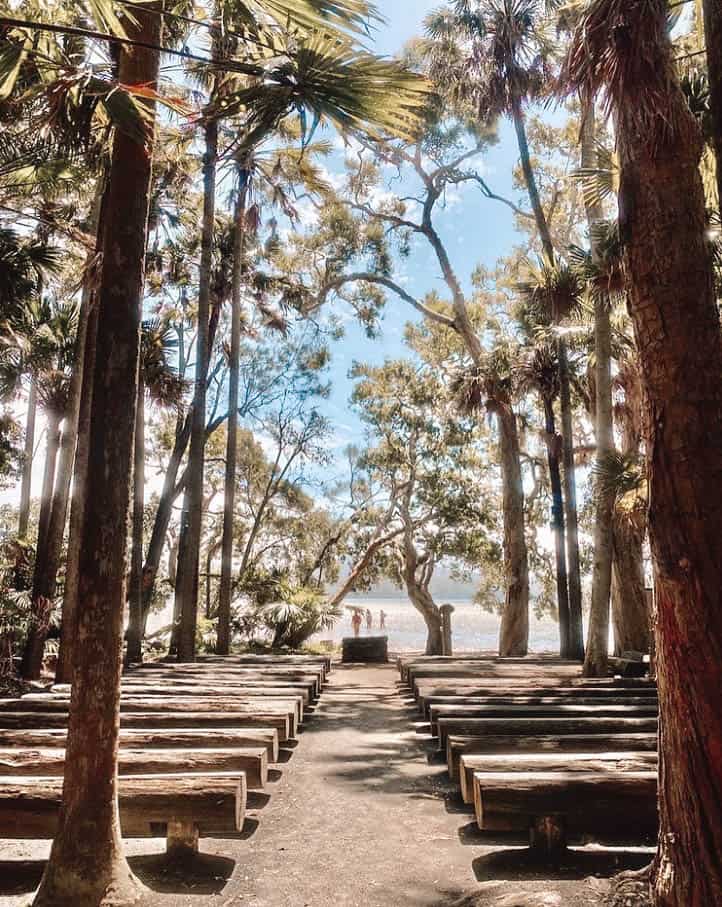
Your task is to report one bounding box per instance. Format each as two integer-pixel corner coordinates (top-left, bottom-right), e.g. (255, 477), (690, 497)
(0, 727), (279, 762)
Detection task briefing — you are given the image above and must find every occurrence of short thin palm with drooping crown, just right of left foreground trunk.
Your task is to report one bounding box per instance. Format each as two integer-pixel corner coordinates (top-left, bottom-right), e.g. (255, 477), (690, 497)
(125, 318), (185, 664)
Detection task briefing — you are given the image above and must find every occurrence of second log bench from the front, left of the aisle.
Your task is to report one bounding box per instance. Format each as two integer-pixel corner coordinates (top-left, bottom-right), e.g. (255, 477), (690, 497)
(0, 746), (268, 790)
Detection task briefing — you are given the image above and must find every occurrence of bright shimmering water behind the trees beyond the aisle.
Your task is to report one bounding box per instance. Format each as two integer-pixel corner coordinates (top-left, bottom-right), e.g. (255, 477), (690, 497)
(311, 596), (559, 653)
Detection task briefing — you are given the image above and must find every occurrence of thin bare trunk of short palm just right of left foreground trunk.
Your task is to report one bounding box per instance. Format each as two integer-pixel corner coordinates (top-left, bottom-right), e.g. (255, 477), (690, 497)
(125, 374), (145, 664)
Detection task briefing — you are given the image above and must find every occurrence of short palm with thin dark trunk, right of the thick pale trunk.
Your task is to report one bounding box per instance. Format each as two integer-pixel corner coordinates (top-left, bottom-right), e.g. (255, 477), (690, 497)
(517, 339), (570, 653)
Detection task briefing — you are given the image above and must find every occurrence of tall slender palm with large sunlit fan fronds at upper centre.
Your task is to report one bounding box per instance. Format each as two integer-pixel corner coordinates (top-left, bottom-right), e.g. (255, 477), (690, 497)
(175, 21), (428, 661)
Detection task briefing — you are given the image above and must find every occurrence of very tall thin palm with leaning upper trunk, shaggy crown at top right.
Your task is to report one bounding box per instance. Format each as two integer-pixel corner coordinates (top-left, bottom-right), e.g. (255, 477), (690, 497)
(425, 0), (584, 658)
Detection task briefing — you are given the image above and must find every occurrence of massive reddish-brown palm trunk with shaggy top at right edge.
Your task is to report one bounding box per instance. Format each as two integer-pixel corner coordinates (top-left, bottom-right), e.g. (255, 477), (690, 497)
(564, 0), (722, 907)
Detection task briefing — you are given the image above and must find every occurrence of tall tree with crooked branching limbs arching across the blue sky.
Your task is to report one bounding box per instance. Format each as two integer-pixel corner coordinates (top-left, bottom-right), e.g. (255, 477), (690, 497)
(280, 122), (529, 654)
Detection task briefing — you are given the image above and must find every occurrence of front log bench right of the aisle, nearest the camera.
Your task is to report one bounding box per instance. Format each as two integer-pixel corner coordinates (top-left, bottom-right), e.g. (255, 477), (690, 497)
(474, 772), (657, 857)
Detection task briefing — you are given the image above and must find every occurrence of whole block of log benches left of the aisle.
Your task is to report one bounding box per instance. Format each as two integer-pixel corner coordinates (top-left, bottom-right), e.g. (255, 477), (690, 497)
(0, 655), (330, 852)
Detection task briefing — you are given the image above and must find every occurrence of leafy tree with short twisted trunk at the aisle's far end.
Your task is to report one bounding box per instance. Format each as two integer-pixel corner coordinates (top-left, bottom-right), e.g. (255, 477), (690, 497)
(353, 360), (491, 655)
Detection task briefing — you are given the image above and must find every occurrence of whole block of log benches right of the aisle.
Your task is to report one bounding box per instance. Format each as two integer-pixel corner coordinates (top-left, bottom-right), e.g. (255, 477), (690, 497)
(398, 656), (658, 856)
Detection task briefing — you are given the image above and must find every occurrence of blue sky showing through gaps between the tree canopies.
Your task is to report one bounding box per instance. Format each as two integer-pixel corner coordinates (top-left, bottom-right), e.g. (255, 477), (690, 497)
(316, 0), (519, 462)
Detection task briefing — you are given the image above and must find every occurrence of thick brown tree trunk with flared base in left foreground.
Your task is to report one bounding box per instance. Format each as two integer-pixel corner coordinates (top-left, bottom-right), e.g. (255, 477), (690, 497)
(34, 4), (162, 907)
